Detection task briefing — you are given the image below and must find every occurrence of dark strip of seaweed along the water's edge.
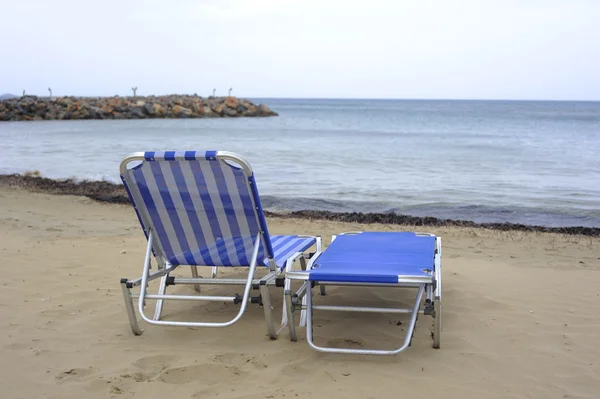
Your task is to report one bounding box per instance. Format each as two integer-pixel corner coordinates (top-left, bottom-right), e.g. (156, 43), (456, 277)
(0, 174), (600, 237)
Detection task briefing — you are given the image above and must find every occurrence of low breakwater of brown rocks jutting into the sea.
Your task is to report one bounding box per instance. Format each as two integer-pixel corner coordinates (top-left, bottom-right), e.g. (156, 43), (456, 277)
(0, 95), (277, 121)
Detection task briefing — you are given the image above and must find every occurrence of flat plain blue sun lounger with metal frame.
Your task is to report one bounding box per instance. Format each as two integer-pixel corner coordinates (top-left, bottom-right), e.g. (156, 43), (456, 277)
(284, 232), (442, 355)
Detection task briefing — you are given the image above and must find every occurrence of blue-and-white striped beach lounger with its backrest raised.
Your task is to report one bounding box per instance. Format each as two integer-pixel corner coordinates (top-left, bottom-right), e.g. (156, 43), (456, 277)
(120, 151), (321, 339)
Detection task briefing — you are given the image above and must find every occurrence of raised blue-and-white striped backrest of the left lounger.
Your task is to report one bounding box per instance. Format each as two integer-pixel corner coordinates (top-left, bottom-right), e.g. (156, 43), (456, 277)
(121, 151), (275, 268)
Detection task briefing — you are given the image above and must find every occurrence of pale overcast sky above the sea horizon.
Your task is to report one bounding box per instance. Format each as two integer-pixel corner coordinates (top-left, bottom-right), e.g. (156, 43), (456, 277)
(0, 0), (600, 100)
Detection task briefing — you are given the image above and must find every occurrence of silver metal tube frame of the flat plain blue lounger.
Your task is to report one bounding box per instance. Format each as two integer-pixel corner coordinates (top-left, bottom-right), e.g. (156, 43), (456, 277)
(284, 232), (442, 355)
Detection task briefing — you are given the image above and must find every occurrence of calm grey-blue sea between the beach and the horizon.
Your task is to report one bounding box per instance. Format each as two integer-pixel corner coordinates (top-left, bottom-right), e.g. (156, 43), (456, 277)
(0, 99), (600, 227)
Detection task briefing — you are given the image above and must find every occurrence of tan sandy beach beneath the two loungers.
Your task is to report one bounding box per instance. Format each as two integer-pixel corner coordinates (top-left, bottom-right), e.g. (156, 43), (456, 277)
(0, 187), (600, 398)
